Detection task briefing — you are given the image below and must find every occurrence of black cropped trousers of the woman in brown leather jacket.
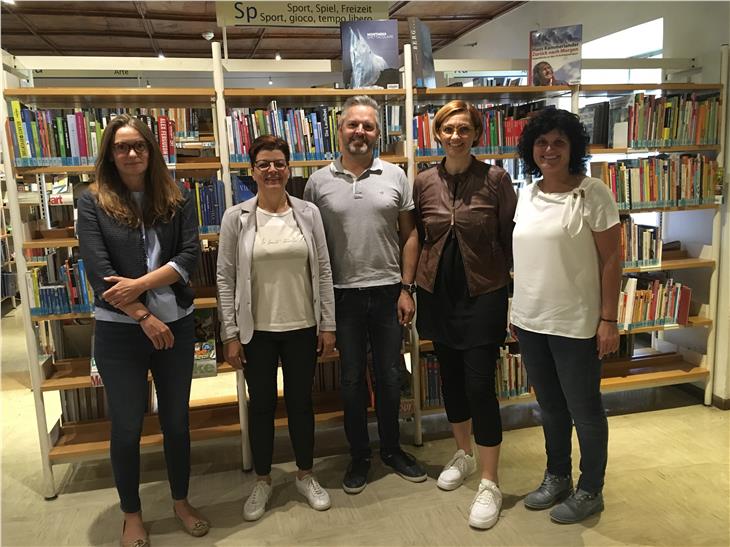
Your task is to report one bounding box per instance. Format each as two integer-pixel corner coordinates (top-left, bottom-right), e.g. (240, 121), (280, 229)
(433, 342), (502, 446)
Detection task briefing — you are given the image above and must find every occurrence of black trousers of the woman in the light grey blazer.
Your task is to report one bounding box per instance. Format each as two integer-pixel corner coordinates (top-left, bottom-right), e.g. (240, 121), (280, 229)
(244, 327), (317, 476)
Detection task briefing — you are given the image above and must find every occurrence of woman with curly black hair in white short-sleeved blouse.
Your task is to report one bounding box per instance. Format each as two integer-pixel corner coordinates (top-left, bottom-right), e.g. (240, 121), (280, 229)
(510, 108), (621, 523)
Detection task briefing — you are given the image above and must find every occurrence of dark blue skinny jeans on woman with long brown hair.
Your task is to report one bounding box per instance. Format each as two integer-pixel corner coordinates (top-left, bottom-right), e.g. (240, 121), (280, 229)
(94, 314), (195, 513)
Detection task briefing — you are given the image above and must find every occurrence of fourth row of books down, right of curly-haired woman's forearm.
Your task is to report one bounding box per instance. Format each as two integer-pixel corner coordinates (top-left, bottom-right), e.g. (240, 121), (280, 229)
(618, 272), (692, 330)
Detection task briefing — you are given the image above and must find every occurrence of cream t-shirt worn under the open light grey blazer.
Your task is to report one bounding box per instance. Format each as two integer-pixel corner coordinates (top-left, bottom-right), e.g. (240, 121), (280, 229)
(251, 208), (317, 332)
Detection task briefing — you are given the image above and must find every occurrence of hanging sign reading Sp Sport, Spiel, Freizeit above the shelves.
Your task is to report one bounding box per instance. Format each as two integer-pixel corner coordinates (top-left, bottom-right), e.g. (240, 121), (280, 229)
(215, 2), (390, 27)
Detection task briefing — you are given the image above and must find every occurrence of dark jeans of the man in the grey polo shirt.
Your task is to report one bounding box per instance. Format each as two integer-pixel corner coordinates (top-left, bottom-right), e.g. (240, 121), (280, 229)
(335, 283), (402, 458)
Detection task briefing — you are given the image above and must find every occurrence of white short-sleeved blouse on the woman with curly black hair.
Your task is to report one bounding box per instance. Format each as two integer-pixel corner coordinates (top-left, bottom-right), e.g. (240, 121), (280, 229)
(510, 177), (620, 338)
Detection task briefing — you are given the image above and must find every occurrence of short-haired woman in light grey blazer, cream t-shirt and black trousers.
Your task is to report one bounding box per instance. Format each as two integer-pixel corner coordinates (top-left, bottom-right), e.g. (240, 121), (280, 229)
(217, 135), (335, 520)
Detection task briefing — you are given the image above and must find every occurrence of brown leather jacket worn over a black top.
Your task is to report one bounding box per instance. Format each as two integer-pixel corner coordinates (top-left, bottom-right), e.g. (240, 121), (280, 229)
(413, 157), (517, 296)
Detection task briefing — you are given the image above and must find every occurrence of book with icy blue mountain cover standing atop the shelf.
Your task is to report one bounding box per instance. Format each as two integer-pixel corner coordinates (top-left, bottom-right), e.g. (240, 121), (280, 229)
(340, 20), (400, 89)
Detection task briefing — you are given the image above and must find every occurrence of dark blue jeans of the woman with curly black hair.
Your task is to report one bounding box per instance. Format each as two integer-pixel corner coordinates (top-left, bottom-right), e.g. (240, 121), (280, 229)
(516, 328), (608, 493)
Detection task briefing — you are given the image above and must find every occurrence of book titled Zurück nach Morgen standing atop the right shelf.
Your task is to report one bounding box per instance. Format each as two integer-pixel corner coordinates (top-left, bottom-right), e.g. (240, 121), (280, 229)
(529, 25), (583, 85)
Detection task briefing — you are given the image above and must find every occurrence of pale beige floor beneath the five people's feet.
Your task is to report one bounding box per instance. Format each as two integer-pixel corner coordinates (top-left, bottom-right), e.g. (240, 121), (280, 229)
(1, 308), (730, 546)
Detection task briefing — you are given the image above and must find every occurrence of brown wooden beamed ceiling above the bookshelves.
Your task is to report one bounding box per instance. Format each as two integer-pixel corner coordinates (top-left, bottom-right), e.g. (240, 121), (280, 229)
(0, 0), (524, 59)
